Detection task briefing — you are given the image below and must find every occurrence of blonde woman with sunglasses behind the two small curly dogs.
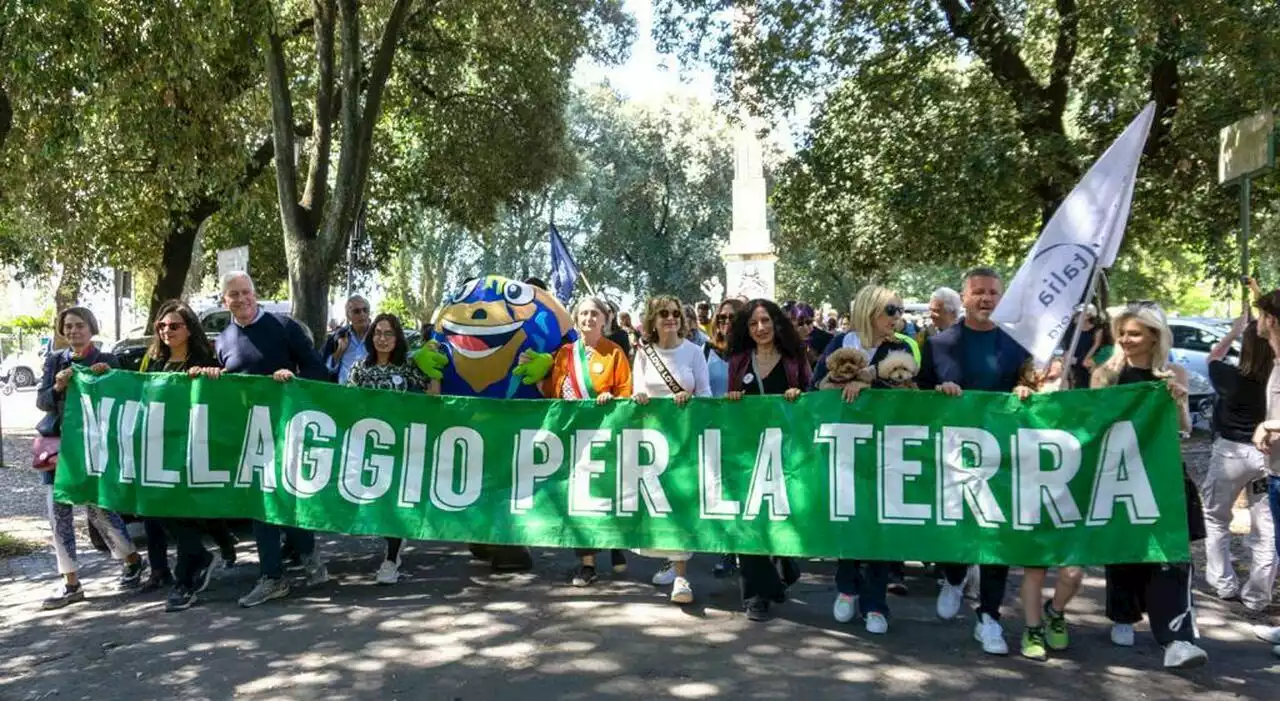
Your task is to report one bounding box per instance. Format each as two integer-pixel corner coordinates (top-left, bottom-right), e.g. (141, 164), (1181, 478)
(814, 285), (916, 634)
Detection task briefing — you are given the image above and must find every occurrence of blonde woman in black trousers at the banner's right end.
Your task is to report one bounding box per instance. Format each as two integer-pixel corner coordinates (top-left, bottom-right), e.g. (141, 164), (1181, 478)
(1091, 302), (1208, 669)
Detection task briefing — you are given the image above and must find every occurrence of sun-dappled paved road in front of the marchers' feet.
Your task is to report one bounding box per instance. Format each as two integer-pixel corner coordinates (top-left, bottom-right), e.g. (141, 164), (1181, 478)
(0, 536), (1280, 701)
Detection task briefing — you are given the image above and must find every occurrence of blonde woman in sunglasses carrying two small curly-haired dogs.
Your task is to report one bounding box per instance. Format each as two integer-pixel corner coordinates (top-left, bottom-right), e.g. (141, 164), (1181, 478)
(814, 285), (919, 634)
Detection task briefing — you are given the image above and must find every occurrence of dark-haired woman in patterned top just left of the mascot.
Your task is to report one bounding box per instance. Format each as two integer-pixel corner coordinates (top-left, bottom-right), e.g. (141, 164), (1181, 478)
(347, 313), (440, 585)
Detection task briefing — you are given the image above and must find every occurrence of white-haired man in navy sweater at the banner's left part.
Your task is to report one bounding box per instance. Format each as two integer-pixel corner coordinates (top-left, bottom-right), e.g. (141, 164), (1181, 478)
(216, 272), (329, 608)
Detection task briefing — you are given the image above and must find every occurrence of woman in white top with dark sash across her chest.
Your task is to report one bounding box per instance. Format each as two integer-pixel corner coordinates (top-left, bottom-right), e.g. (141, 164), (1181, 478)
(631, 295), (712, 604)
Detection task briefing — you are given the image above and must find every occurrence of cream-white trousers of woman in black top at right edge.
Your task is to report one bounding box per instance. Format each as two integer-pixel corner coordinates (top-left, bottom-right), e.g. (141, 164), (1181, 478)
(1201, 437), (1276, 610)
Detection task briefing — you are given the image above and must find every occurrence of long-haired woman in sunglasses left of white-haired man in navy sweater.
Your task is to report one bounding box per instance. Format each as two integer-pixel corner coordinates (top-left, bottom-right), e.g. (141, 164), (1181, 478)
(138, 299), (236, 611)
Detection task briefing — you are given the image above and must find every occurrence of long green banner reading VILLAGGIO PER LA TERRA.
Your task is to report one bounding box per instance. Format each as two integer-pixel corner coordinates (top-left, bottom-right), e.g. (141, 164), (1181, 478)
(55, 371), (1189, 565)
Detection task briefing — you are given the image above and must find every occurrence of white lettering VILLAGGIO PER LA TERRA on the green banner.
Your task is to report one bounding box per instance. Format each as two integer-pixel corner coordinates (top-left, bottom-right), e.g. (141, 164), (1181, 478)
(81, 397), (1160, 530)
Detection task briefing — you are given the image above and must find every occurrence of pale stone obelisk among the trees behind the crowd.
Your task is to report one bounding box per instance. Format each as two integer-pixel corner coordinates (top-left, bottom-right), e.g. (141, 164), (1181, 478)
(721, 120), (778, 299)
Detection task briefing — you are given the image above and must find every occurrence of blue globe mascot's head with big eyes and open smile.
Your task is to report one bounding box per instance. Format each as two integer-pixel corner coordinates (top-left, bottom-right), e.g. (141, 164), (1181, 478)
(434, 275), (573, 399)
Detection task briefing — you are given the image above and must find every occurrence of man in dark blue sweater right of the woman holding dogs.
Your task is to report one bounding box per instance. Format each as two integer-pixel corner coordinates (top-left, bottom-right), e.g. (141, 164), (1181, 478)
(918, 267), (1033, 655)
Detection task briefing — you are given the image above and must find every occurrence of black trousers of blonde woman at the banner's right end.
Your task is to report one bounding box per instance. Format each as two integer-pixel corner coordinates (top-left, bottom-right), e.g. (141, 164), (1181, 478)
(1106, 563), (1196, 646)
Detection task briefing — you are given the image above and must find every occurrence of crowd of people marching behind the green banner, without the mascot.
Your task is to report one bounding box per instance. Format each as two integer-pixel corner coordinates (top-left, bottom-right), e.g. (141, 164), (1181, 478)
(27, 269), (1280, 668)
